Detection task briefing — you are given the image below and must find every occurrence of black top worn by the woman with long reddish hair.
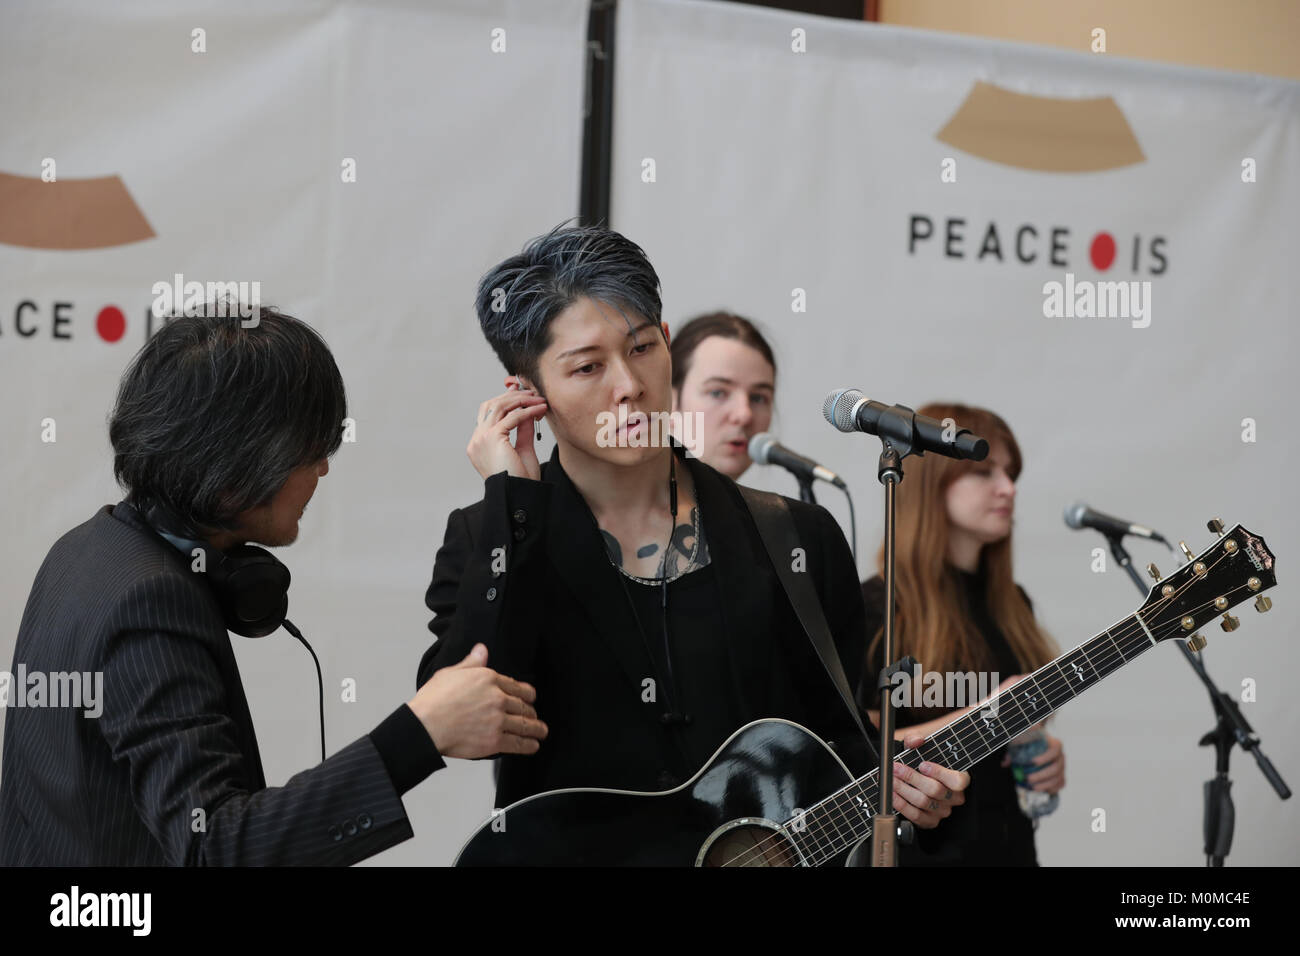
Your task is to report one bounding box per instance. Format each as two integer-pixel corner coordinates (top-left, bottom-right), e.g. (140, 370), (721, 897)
(862, 566), (1037, 866)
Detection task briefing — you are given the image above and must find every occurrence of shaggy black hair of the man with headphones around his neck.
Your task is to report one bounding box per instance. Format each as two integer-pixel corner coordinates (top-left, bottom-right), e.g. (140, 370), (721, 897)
(108, 306), (347, 532)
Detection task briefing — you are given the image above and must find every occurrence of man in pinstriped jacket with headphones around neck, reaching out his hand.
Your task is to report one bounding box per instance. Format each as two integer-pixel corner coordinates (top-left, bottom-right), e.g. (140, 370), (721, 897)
(0, 308), (546, 866)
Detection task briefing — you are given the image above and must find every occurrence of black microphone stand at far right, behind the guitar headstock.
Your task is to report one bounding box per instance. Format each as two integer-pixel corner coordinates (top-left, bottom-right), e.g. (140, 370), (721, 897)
(1102, 525), (1291, 868)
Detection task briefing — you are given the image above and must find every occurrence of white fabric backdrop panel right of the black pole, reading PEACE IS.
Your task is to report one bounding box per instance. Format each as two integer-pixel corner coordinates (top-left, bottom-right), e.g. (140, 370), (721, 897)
(611, 0), (1300, 866)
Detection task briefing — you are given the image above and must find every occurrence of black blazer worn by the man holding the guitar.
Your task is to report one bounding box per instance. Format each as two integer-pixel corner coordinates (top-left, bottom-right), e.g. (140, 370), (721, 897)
(419, 447), (875, 806)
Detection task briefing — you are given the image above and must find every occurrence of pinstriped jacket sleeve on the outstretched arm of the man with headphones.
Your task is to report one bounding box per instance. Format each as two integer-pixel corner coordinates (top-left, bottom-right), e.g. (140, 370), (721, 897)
(98, 574), (431, 865)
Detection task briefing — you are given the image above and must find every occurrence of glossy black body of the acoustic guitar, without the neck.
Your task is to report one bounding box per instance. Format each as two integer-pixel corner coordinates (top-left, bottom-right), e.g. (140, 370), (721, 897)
(456, 719), (853, 866)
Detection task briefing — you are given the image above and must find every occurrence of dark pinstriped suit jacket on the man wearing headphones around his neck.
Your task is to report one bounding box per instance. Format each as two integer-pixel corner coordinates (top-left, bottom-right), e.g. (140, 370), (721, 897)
(0, 503), (412, 866)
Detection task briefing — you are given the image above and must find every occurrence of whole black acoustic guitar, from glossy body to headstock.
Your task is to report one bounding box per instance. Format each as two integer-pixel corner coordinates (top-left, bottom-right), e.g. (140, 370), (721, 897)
(456, 522), (1277, 866)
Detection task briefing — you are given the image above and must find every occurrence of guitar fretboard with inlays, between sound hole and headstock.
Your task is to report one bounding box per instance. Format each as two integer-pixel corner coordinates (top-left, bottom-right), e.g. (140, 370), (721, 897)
(783, 611), (1167, 866)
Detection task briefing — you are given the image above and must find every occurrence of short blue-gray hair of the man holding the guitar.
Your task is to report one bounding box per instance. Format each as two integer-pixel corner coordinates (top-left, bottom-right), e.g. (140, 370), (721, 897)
(475, 225), (663, 388)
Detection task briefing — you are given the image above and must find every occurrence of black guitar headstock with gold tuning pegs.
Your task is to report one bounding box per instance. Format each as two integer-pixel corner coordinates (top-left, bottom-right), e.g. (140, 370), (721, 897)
(1138, 519), (1278, 650)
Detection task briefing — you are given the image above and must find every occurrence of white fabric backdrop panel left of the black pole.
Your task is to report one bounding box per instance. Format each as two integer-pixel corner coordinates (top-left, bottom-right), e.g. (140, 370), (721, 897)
(0, 0), (586, 864)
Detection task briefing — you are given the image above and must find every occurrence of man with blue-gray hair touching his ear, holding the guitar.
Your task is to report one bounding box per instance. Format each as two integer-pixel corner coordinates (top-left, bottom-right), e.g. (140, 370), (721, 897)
(419, 228), (969, 862)
